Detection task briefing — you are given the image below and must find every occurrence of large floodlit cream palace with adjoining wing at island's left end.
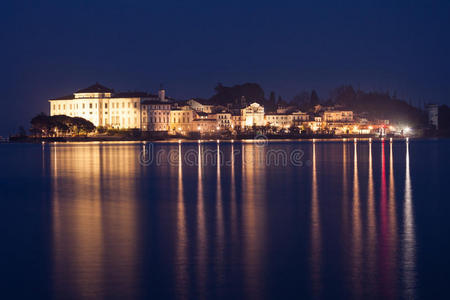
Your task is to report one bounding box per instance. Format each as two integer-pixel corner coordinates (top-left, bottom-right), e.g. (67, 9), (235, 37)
(49, 83), (170, 131)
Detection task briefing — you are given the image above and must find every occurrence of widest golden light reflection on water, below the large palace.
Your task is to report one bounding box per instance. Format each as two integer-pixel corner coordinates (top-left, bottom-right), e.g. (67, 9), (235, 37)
(51, 145), (138, 298)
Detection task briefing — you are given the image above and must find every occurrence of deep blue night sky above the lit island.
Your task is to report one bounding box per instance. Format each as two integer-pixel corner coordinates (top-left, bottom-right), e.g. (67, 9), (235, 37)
(0, 1), (450, 135)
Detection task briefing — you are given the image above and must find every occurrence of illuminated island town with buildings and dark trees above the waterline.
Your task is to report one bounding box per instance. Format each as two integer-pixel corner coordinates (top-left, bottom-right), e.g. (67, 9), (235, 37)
(20, 82), (422, 140)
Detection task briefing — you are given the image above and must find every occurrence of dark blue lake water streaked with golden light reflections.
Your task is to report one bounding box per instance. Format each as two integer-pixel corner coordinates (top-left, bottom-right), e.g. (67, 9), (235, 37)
(0, 140), (450, 299)
